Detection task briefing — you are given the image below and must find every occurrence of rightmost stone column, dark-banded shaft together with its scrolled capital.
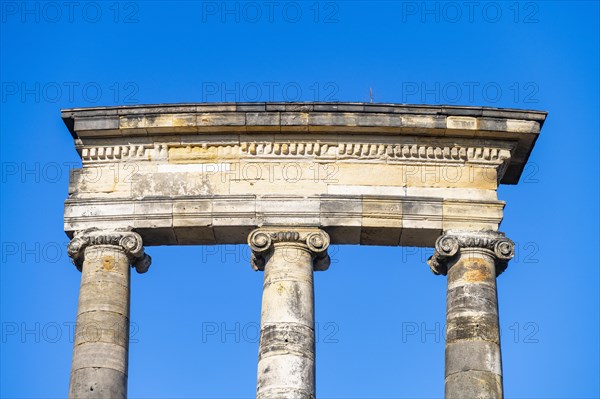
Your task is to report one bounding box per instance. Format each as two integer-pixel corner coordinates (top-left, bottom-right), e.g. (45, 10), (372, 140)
(428, 230), (514, 399)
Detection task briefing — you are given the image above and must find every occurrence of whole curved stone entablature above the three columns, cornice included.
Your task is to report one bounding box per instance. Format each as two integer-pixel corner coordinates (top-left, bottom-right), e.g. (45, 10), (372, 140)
(62, 103), (546, 246)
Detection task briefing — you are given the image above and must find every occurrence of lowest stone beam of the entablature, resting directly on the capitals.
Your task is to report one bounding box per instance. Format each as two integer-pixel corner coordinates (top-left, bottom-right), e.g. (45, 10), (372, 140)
(65, 195), (504, 246)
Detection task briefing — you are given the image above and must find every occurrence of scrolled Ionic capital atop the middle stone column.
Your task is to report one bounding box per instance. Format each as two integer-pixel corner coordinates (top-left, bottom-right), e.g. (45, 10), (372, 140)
(248, 228), (330, 271)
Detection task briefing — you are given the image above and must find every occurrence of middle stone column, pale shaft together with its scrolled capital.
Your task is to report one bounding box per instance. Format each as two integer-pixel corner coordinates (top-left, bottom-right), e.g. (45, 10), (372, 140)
(248, 228), (330, 399)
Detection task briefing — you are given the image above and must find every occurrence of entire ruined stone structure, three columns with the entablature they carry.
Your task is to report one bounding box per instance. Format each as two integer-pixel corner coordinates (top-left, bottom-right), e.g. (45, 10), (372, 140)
(62, 103), (546, 399)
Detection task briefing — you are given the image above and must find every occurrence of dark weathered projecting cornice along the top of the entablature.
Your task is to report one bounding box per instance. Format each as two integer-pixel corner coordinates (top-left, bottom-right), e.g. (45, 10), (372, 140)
(61, 102), (547, 184)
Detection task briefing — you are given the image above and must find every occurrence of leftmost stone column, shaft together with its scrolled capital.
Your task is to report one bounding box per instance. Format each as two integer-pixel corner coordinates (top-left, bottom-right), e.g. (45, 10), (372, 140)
(68, 229), (150, 399)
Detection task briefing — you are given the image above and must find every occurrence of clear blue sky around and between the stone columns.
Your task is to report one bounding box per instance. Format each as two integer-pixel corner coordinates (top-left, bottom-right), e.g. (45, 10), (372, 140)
(0, 1), (600, 398)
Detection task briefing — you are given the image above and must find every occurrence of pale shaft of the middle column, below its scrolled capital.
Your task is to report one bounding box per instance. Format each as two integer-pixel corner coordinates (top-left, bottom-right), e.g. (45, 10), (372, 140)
(257, 244), (315, 399)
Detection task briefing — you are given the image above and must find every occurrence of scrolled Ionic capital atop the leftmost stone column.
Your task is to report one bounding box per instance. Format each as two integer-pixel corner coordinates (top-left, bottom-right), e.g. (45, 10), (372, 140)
(67, 228), (152, 273)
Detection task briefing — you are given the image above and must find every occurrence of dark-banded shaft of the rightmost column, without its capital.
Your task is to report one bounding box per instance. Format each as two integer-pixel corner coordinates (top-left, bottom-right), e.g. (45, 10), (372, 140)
(445, 249), (503, 399)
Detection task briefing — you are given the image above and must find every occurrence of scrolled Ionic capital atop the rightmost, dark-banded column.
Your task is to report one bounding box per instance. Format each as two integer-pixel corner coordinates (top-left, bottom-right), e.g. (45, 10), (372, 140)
(427, 230), (515, 276)
